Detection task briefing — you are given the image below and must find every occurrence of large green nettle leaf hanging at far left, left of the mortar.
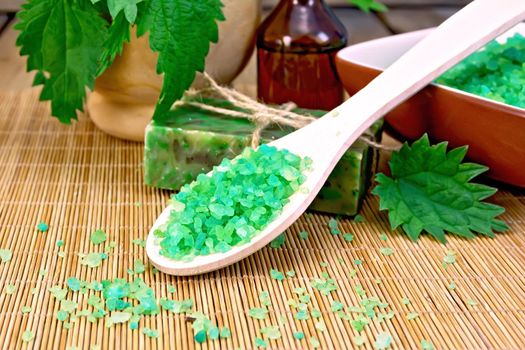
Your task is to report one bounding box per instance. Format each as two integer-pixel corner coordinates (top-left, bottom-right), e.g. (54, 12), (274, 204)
(16, 0), (108, 124)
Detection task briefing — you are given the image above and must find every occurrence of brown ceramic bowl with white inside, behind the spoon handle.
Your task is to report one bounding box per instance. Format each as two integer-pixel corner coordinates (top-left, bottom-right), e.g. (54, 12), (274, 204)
(337, 24), (525, 187)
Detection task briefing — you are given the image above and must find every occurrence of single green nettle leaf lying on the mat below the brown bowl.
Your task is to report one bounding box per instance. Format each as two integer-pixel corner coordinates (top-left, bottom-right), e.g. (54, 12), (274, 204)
(373, 135), (508, 242)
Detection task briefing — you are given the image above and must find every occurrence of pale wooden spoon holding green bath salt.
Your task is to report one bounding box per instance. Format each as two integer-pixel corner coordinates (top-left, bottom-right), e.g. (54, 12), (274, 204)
(146, 0), (525, 275)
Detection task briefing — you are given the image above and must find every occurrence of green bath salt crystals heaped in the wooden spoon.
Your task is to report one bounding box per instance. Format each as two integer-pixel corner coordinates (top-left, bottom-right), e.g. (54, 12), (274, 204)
(155, 145), (311, 260)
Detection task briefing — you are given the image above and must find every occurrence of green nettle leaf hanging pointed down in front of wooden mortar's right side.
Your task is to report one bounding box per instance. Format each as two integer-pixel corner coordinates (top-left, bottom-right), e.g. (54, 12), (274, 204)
(137, 0), (224, 120)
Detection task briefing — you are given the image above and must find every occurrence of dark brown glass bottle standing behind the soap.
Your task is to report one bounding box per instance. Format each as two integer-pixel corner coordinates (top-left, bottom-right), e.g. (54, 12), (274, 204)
(257, 0), (347, 110)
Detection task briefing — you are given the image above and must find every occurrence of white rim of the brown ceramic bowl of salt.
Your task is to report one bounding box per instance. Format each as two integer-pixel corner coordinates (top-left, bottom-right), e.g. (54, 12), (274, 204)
(337, 23), (525, 118)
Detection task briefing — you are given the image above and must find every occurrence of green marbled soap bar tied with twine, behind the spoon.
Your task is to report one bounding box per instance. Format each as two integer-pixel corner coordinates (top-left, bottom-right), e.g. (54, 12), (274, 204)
(144, 98), (383, 215)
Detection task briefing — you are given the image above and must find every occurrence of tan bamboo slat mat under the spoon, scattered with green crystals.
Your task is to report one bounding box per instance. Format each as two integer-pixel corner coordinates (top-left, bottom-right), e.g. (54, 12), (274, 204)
(0, 92), (525, 349)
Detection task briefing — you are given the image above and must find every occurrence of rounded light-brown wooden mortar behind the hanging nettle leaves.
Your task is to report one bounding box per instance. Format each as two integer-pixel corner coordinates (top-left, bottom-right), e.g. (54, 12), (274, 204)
(87, 0), (261, 141)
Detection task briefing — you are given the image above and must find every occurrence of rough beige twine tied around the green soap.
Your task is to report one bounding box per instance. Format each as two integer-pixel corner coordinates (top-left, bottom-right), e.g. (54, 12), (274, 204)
(174, 73), (391, 150)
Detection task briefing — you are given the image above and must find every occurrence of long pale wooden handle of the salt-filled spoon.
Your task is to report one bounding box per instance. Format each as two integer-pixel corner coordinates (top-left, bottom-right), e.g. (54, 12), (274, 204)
(328, 0), (525, 152)
